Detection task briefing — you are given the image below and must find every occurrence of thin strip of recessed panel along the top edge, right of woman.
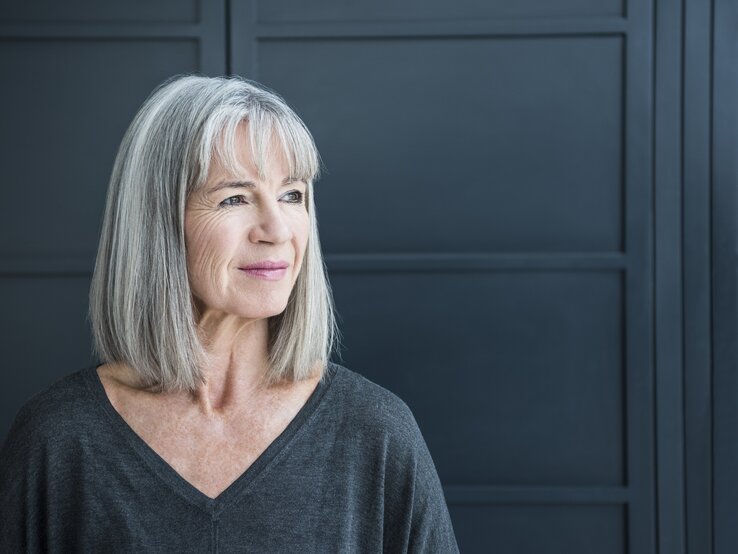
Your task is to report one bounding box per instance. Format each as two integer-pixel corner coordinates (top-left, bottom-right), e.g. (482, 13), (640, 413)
(258, 0), (623, 23)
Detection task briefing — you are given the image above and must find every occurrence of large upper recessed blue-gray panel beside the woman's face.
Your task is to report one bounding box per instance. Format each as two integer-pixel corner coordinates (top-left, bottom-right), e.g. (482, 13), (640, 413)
(259, 37), (623, 253)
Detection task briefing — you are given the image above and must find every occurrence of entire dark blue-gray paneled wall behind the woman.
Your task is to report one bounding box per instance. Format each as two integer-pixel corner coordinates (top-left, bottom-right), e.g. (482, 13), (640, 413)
(0, 0), (738, 554)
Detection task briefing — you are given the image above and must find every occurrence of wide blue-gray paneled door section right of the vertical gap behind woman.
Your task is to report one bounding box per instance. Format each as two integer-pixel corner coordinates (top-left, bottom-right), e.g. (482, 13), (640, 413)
(231, 0), (655, 553)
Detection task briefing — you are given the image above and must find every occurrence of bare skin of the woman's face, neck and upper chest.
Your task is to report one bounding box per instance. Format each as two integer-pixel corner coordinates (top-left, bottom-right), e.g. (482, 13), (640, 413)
(98, 123), (319, 498)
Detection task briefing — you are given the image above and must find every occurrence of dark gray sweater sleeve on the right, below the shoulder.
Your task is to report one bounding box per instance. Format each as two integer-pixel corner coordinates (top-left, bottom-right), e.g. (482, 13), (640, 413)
(384, 406), (459, 554)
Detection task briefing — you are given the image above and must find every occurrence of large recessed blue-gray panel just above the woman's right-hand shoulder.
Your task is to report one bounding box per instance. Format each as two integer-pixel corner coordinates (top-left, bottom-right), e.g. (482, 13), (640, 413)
(331, 271), (625, 486)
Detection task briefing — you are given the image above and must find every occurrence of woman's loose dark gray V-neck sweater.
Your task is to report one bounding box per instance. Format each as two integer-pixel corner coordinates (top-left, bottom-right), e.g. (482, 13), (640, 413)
(0, 364), (458, 554)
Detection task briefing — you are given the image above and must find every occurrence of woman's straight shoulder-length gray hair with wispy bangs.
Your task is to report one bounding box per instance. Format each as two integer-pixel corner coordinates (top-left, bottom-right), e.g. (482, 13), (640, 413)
(90, 76), (338, 391)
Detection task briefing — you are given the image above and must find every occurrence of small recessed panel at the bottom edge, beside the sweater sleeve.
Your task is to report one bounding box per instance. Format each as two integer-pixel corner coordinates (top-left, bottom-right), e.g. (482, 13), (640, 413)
(449, 505), (628, 554)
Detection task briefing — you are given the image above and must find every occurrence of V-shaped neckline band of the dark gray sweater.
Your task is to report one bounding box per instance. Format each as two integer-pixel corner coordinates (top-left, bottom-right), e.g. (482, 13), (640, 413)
(82, 362), (339, 517)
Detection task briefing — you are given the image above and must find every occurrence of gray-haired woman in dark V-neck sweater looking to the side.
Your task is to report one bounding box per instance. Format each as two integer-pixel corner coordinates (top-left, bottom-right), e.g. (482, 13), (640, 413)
(0, 76), (458, 553)
